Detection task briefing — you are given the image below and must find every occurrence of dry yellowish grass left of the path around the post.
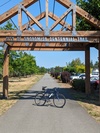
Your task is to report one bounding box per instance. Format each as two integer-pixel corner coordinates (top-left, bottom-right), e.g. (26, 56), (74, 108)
(0, 75), (43, 115)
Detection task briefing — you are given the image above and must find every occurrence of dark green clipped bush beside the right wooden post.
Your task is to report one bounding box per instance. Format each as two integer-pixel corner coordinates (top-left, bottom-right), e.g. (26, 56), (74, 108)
(72, 79), (85, 92)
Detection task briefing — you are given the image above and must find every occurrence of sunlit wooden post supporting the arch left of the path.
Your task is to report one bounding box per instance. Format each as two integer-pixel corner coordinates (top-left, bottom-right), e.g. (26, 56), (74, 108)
(3, 47), (9, 98)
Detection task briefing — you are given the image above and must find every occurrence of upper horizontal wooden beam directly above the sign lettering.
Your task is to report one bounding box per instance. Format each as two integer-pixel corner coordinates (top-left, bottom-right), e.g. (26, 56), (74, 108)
(0, 30), (100, 39)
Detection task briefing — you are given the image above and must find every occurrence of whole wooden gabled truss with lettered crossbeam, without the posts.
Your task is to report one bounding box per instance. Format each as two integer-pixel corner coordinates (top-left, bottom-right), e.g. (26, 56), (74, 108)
(0, 0), (100, 50)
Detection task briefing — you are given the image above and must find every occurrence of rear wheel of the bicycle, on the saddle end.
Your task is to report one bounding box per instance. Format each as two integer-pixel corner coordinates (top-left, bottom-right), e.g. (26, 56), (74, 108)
(35, 93), (46, 106)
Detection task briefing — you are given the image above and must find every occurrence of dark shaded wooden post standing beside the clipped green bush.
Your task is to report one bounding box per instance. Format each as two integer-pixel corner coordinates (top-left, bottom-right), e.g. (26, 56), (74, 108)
(85, 46), (91, 95)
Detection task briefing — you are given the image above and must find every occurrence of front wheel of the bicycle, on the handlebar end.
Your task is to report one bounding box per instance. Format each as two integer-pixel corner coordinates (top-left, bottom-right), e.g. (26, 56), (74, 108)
(53, 94), (66, 108)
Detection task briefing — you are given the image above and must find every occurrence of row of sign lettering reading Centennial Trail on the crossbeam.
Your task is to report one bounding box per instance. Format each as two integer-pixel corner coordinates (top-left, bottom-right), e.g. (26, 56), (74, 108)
(5, 36), (89, 43)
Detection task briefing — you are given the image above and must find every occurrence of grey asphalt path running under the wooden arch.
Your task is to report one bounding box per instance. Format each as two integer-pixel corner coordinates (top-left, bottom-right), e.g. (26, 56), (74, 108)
(0, 74), (100, 133)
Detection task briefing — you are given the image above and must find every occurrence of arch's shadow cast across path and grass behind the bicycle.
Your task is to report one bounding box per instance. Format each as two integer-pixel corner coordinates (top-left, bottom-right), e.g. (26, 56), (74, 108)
(0, 87), (100, 106)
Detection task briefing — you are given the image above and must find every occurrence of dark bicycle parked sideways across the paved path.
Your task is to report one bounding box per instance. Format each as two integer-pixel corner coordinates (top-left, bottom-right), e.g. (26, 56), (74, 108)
(35, 86), (66, 108)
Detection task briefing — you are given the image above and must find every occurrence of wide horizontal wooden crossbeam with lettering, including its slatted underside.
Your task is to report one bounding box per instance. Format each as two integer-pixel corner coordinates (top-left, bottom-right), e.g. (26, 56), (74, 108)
(0, 30), (100, 51)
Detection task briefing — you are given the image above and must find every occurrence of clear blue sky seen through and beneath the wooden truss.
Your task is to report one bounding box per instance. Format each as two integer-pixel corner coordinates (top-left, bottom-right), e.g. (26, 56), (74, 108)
(0, 0), (98, 68)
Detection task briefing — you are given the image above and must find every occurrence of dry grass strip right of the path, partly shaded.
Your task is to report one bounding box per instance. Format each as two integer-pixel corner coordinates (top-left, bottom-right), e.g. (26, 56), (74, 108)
(59, 83), (100, 123)
